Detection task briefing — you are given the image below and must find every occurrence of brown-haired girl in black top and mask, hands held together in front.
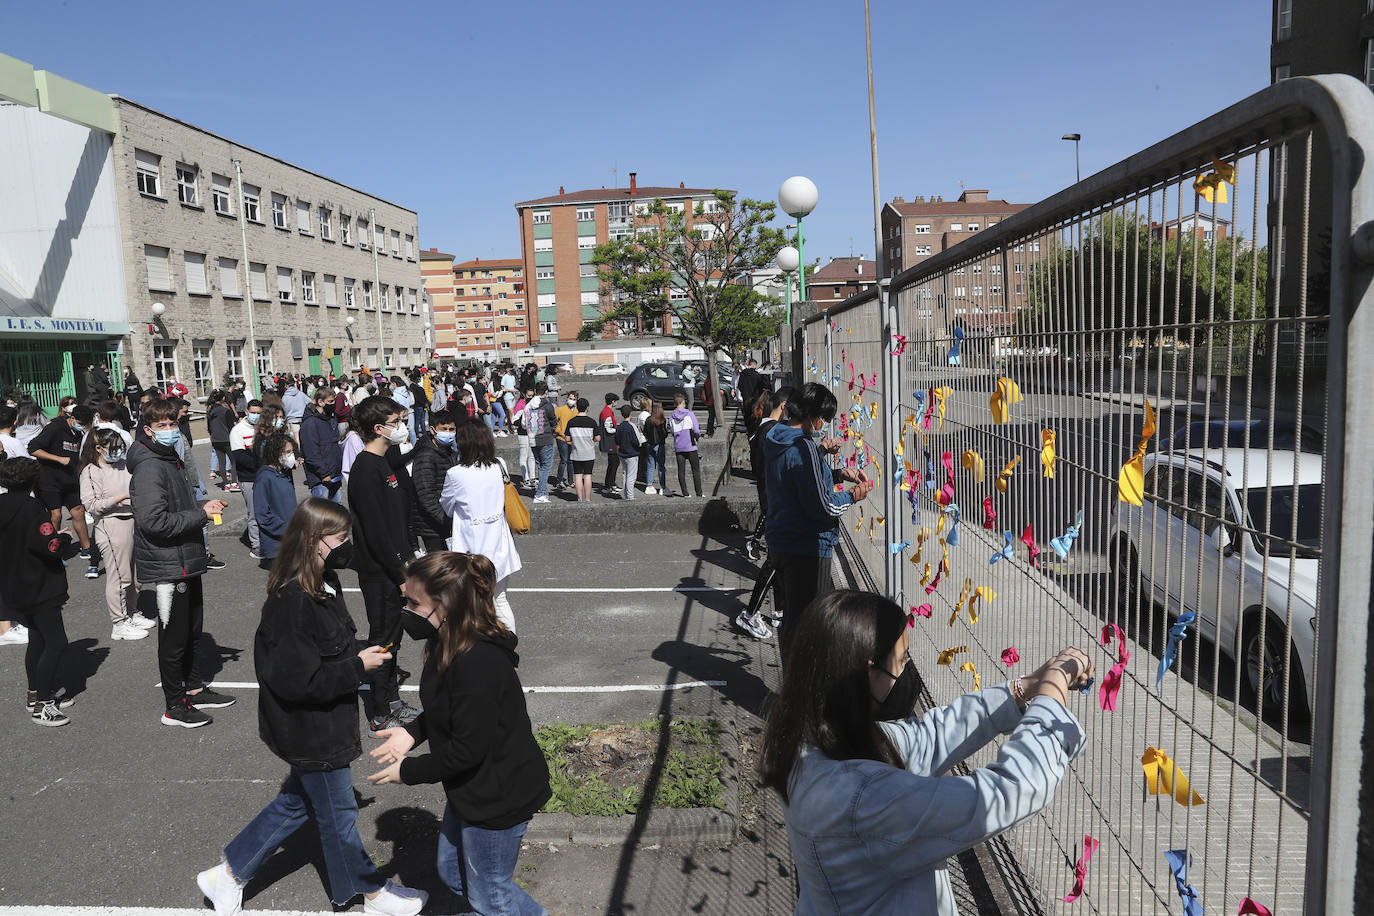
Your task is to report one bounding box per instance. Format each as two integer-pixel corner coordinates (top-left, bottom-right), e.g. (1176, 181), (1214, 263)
(368, 551), (551, 916)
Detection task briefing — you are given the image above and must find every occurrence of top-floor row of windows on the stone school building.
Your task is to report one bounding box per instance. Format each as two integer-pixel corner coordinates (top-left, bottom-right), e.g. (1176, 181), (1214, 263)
(133, 150), (415, 261)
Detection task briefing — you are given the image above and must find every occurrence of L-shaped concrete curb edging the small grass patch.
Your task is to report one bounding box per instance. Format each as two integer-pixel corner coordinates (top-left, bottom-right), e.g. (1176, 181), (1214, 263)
(525, 720), (739, 846)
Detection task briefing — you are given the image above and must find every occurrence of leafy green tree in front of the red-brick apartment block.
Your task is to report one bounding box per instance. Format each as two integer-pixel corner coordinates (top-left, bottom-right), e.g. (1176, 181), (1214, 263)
(577, 191), (786, 417)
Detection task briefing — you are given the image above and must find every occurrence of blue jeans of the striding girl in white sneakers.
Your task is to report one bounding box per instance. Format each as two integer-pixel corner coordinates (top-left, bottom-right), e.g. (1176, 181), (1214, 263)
(224, 766), (384, 905)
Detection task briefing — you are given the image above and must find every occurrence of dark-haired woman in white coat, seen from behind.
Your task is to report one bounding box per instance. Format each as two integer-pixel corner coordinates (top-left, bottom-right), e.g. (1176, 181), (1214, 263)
(440, 420), (521, 633)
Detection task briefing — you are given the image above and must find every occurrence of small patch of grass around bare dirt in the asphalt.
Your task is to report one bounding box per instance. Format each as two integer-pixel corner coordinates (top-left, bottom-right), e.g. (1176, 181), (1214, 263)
(534, 720), (724, 816)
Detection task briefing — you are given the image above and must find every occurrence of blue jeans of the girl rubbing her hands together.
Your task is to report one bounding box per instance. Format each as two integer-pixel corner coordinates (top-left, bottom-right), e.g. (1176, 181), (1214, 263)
(439, 805), (548, 916)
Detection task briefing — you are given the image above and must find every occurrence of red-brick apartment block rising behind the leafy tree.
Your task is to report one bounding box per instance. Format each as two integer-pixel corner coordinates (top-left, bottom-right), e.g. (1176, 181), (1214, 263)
(515, 172), (716, 343)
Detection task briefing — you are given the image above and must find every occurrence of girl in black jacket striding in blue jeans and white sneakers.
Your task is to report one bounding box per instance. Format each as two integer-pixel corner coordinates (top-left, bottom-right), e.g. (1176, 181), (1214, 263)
(195, 497), (429, 916)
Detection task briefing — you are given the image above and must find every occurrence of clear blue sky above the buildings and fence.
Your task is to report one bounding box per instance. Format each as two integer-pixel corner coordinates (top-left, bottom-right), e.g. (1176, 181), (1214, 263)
(0, 0), (1270, 260)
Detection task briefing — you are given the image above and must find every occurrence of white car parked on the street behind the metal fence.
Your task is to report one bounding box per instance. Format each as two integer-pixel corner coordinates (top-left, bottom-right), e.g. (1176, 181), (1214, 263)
(1112, 449), (1322, 722)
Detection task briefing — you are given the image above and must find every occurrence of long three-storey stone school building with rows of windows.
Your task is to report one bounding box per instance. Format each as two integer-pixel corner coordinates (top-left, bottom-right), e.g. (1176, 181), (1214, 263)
(114, 96), (427, 397)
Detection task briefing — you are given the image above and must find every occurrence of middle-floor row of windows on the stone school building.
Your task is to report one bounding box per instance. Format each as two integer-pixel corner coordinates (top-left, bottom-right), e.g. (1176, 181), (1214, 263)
(143, 244), (419, 314)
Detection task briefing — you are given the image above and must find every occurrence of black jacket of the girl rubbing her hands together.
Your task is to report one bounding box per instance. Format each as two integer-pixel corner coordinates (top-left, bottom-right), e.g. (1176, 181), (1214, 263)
(401, 633), (552, 829)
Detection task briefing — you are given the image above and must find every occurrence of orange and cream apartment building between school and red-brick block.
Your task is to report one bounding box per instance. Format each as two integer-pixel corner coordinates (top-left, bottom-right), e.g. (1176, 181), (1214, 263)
(420, 249), (530, 360)
